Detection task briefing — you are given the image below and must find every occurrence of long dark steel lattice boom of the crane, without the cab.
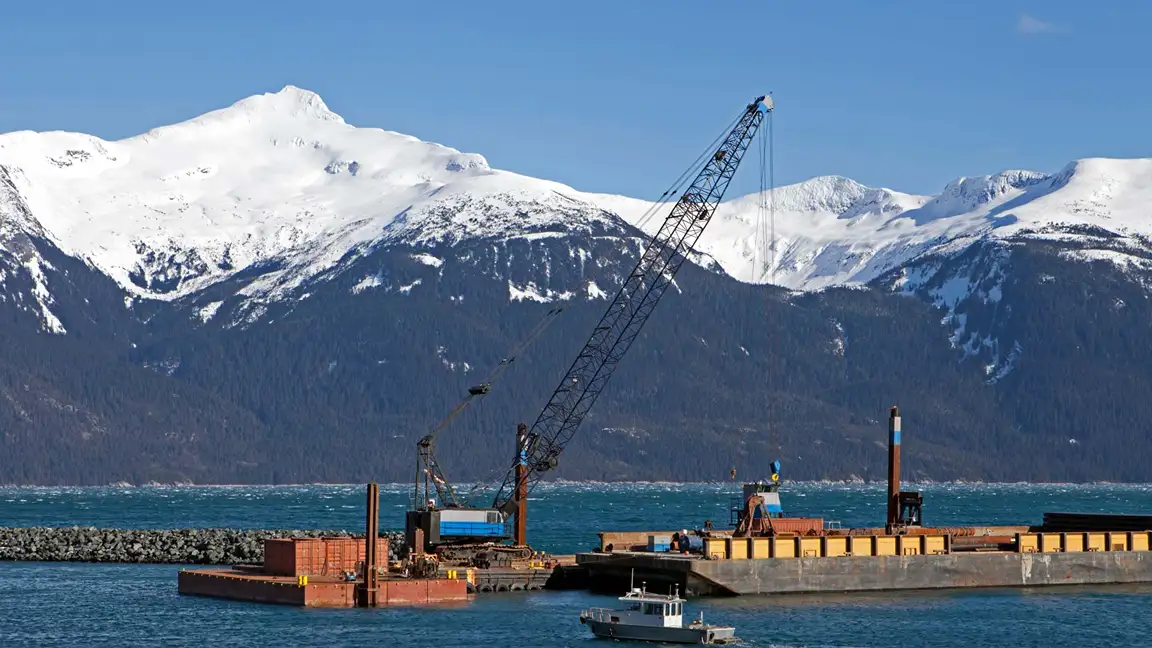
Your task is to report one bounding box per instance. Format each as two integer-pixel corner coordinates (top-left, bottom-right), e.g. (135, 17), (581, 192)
(493, 97), (774, 514)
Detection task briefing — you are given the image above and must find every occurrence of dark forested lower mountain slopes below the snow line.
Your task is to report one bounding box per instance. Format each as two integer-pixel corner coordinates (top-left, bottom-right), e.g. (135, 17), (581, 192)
(0, 229), (1152, 484)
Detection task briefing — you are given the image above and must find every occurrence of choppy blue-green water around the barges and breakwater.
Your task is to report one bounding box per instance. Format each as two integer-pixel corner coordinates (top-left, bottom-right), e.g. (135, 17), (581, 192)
(0, 483), (1152, 648)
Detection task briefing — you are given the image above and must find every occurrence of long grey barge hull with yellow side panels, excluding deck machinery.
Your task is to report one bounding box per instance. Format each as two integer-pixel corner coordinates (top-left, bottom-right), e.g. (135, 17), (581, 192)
(576, 532), (1152, 596)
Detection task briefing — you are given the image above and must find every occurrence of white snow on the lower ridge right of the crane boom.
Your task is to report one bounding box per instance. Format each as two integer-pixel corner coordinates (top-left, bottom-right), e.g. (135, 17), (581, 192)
(599, 159), (1152, 291)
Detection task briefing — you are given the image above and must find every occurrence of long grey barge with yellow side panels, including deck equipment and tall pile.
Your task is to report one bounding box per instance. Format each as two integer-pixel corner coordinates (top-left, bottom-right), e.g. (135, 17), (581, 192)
(576, 407), (1152, 596)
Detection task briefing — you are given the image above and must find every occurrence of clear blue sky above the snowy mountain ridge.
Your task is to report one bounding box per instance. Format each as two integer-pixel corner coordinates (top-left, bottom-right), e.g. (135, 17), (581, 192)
(0, 0), (1152, 197)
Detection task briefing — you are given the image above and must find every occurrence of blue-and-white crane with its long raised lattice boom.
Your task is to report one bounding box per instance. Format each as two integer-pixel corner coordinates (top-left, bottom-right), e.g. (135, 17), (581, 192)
(406, 96), (774, 559)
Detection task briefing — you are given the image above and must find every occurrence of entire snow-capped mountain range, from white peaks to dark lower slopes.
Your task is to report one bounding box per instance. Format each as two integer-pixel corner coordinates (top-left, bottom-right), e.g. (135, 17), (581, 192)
(0, 86), (1152, 483)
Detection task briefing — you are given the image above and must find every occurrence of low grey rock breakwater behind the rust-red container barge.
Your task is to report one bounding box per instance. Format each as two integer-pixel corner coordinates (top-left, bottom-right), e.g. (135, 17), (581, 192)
(0, 527), (404, 565)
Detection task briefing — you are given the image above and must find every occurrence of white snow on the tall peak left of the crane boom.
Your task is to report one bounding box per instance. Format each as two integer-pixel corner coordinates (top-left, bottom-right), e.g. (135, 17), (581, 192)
(0, 86), (626, 299)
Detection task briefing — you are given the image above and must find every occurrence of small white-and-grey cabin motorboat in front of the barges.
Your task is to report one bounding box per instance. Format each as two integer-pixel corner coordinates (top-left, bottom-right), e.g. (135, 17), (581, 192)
(579, 587), (736, 645)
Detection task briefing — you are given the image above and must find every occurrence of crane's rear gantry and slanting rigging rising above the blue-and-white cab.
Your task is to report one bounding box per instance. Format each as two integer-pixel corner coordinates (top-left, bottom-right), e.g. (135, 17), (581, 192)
(412, 307), (564, 511)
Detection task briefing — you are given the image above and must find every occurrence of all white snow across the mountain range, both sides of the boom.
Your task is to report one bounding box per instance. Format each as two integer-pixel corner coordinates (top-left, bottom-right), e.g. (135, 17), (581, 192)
(0, 86), (1152, 299)
